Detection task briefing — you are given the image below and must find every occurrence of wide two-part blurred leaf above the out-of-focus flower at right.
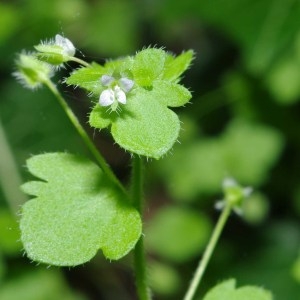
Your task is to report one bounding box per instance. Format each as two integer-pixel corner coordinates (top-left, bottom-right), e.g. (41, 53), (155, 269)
(157, 120), (283, 200)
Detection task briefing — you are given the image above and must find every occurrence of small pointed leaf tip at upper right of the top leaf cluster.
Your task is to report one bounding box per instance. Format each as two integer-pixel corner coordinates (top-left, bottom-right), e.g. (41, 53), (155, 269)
(162, 50), (194, 81)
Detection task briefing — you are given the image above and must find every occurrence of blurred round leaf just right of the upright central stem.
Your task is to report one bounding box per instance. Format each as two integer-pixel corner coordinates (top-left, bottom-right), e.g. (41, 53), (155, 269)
(146, 207), (211, 263)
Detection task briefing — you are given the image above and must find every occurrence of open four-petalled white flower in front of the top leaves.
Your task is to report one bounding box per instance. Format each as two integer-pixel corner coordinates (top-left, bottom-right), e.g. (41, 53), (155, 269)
(99, 75), (134, 110)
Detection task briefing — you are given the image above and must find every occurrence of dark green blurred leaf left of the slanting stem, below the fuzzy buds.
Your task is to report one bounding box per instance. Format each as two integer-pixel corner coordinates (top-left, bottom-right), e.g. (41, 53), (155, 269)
(0, 82), (86, 166)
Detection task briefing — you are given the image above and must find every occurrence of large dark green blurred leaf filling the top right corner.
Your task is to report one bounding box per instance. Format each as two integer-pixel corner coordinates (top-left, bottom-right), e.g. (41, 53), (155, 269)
(160, 0), (300, 74)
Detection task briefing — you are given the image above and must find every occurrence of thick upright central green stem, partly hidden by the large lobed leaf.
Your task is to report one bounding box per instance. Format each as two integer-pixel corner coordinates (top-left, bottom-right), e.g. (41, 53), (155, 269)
(131, 157), (151, 300)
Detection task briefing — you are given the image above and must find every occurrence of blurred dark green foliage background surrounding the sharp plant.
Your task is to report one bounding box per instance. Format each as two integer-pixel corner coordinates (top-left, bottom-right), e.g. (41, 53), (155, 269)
(0, 0), (300, 300)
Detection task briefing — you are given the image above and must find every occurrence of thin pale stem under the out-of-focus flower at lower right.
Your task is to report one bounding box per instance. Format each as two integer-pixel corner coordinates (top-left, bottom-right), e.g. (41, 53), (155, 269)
(184, 204), (232, 300)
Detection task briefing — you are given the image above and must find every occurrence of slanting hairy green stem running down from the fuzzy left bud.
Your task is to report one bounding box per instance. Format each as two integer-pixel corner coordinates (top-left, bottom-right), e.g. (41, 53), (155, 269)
(45, 80), (125, 191)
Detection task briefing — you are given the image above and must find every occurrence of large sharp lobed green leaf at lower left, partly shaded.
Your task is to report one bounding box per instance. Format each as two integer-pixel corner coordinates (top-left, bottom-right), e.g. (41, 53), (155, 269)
(20, 153), (141, 266)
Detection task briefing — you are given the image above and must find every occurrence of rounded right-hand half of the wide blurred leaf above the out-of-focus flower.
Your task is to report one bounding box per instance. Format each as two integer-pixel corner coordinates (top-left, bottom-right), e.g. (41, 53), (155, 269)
(221, 120), (283, 186)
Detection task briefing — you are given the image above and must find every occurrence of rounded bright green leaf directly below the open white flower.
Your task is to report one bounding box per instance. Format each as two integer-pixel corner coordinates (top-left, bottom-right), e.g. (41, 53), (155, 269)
(111, 88), (180, 159)
